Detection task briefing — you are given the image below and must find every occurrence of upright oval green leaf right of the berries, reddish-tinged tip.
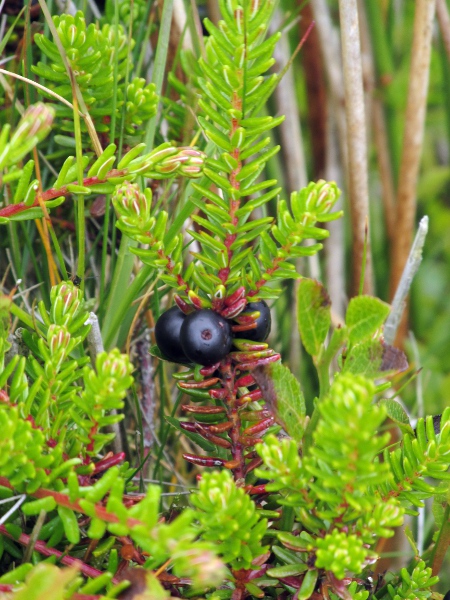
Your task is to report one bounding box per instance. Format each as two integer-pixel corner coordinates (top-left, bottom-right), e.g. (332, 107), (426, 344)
(297, 278), (331, 356)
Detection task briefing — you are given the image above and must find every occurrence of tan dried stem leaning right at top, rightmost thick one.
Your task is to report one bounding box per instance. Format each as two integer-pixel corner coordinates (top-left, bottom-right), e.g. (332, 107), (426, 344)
(390, 0), (436, 304)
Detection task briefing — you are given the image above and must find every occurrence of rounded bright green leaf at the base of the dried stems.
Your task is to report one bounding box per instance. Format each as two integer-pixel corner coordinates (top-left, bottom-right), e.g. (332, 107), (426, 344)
(345, 296), (390, 344)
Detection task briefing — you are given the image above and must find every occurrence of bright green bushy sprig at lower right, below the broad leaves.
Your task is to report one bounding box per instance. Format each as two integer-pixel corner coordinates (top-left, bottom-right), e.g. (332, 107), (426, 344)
(257, 375), (403, 578)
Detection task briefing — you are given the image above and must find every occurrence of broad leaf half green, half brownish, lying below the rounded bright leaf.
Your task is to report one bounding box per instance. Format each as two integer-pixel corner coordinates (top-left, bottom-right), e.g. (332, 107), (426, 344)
(342, 340), (408, 377)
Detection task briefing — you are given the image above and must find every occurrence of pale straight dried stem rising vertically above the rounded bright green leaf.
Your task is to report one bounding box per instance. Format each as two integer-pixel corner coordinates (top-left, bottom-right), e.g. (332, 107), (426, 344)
(339, 0), (373, 295)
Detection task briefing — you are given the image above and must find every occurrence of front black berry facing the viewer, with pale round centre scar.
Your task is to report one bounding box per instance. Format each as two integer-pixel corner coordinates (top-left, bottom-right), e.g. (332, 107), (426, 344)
(180, 309), (232, 367)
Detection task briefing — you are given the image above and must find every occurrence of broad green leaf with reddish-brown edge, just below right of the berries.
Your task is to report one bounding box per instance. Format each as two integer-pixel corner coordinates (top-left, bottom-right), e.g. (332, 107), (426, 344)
(252, 362), (306, 444)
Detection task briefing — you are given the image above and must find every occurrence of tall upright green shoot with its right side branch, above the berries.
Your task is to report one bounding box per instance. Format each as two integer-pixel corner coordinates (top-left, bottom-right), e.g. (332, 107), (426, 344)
(114, 0), (340, 306)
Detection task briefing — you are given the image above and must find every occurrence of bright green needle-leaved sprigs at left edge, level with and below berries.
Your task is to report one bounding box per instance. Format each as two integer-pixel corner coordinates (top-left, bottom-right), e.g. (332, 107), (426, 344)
(0, 281), (132, 480)
